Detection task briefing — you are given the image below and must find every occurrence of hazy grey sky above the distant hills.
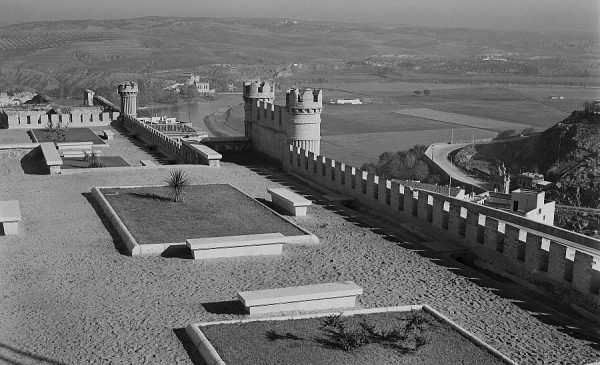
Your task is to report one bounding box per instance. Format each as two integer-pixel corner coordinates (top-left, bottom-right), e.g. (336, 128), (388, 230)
(0, 0), (600, 32)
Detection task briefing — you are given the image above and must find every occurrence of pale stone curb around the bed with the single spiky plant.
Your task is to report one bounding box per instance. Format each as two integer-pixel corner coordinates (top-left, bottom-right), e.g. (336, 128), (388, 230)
(91, 182), (319, 256)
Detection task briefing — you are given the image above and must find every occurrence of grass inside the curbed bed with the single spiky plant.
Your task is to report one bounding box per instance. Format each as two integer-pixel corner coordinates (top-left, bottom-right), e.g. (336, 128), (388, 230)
(101, 184), (305, 244)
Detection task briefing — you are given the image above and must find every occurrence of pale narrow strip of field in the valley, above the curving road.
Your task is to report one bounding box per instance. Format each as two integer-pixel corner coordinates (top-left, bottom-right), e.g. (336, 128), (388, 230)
(394, 108), (531, 132)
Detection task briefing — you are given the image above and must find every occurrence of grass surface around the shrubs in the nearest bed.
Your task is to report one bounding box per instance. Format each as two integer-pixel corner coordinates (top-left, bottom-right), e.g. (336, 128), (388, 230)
(200, 312), (502, 365)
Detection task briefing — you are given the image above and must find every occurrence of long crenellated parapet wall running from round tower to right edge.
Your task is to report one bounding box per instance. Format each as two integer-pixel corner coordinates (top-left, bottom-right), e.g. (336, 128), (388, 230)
(282, 145), (600, 314)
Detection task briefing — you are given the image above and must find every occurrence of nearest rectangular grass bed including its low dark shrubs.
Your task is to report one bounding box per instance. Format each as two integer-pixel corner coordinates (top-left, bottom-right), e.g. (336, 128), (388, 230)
(195, 310), (512, 365)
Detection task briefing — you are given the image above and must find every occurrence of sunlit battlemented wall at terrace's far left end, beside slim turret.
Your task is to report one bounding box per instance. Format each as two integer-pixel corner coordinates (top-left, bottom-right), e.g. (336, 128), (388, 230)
(0, 108), (120, 129)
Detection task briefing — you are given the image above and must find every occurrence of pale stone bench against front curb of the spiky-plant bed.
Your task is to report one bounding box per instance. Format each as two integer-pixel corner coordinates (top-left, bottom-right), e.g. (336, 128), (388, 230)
(186, 233), (285, 260)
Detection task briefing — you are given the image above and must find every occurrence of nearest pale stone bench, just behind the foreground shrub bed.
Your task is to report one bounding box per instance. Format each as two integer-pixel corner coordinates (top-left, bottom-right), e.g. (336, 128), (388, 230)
(237, 281), (363, 314)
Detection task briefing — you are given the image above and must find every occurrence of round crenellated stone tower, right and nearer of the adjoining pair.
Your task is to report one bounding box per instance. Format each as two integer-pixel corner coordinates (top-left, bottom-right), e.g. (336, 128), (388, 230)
(285, 89), (323, 155)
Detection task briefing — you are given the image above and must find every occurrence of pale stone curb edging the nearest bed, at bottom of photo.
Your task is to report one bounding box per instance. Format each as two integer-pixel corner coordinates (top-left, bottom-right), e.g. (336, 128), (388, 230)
(185, 304), (518, 365)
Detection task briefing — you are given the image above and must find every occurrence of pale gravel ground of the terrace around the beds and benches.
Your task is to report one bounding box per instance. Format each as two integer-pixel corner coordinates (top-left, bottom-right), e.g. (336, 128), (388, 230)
(0, 152), (600, 365)
